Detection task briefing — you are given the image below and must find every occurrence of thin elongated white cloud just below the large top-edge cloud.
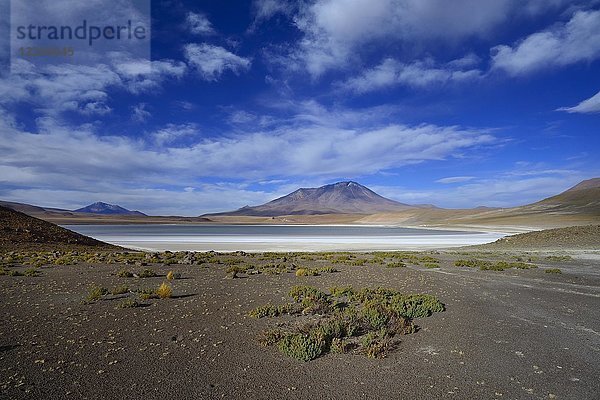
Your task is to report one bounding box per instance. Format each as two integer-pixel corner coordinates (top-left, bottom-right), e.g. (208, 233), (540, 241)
(339, 58), (481, 93)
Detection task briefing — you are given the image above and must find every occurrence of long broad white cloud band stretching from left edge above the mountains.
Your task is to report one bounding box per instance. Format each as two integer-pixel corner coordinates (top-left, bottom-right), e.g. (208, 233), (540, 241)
(0, 100), (496, 209)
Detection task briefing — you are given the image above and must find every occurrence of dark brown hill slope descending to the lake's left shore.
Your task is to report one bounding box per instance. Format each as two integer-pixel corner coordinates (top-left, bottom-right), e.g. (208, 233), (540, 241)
(0, 206), (119, 251)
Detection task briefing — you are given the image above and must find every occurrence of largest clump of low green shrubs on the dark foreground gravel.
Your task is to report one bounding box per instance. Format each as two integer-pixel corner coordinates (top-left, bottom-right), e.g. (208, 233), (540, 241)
(250, 286), (444, 361)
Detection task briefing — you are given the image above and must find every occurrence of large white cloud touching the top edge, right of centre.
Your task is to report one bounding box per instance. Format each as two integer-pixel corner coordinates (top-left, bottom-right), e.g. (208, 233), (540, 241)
(289, 0), (565, 76)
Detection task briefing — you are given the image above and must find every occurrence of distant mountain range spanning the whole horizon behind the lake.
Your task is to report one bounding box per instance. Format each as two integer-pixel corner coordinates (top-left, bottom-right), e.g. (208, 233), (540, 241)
(0, 178), (600, 230)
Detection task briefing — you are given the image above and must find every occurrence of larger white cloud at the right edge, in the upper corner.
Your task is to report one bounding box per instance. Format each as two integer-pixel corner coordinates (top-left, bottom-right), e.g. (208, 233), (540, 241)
(492, 11), (600, 76)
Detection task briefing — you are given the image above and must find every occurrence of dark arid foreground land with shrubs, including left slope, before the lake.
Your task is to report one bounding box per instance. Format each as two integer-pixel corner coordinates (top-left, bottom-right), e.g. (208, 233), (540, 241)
(0, 192), (600, 399)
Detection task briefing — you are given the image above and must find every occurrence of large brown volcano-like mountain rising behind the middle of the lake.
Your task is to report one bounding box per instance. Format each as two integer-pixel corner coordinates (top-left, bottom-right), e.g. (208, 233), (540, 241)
(206, 181), (415, 217)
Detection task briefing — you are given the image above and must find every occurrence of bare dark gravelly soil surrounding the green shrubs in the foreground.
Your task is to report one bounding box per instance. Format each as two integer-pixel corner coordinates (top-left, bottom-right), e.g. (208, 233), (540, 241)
(0, 253), (600, 399)
